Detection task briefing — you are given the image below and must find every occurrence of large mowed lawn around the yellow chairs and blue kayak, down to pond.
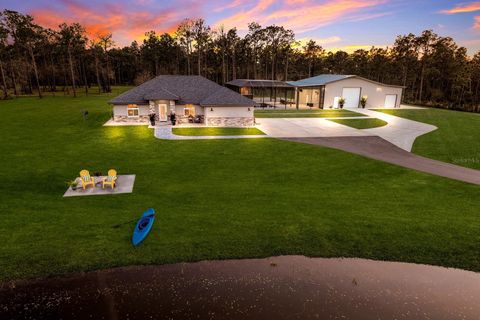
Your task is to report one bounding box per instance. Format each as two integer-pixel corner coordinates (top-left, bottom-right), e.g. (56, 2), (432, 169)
(0, 96), (480, 281)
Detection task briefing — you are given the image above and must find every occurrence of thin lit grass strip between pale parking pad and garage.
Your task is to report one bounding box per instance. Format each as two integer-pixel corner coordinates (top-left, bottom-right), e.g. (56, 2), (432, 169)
(255, 109), (364, 118)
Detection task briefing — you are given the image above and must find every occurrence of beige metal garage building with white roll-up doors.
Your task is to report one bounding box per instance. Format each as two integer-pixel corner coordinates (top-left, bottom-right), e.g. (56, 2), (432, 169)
(288, 74), (404, 109)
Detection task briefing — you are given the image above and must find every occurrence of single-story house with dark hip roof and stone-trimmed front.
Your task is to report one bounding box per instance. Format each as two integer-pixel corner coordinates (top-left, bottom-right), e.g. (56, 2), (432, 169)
(109, 75), (255, 127)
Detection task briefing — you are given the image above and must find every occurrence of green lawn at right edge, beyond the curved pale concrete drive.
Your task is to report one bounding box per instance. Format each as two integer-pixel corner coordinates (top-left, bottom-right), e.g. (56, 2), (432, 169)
(376, 108), (480, 170)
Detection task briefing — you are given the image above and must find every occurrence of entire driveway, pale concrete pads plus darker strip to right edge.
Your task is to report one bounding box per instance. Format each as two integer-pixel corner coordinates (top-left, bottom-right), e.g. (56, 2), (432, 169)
(257, 109), (480, 185)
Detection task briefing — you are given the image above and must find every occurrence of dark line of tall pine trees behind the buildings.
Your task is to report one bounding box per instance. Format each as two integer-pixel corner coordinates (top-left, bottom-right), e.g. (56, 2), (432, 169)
(0, 10), (480, 112)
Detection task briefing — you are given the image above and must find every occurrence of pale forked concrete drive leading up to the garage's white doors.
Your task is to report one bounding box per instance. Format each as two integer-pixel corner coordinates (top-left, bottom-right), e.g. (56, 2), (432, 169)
(356, 109), (437, 151)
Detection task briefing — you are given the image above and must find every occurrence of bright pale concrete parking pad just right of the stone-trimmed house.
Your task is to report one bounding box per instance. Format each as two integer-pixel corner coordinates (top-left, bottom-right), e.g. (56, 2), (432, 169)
(256, 118), (374, 138)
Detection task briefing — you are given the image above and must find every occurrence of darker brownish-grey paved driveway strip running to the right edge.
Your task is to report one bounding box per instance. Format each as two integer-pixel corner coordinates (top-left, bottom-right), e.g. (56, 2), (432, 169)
(284, 136), (480, 185)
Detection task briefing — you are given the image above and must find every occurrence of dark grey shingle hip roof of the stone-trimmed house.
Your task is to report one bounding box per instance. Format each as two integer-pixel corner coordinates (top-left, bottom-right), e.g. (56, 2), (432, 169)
(109, 75), (255, 106)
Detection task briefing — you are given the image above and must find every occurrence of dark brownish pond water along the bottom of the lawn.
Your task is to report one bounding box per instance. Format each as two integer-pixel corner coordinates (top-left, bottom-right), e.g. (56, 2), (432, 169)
(0, 256), (480, 320)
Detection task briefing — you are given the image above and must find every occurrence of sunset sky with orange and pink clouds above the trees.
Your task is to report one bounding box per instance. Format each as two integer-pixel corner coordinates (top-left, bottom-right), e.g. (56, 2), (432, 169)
(0, 0), (480, 54)
